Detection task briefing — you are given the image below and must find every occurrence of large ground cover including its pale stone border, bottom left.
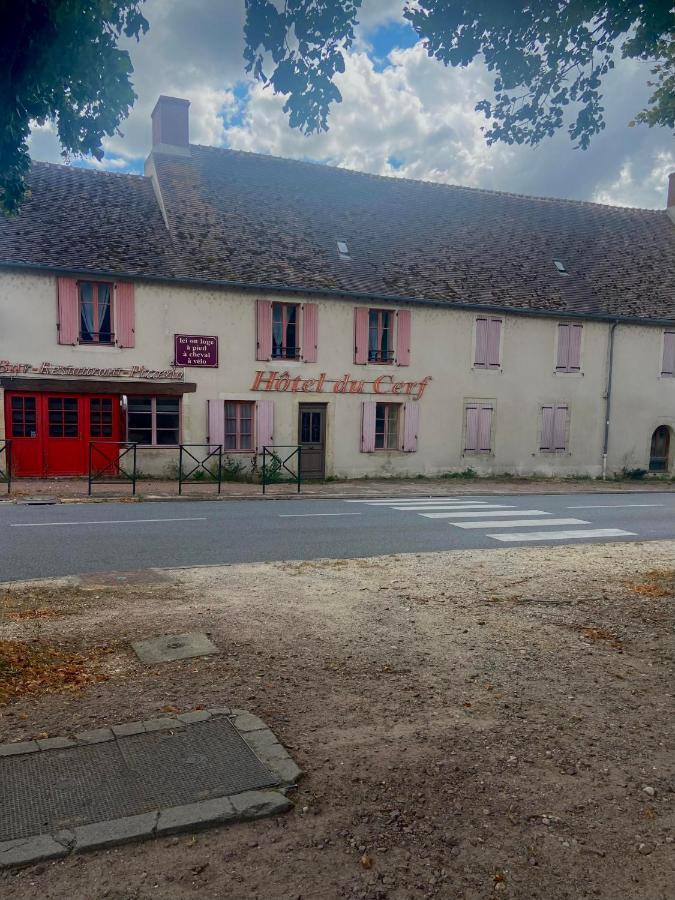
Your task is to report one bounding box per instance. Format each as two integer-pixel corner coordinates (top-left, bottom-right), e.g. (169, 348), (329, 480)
(0, 708), (301, 868)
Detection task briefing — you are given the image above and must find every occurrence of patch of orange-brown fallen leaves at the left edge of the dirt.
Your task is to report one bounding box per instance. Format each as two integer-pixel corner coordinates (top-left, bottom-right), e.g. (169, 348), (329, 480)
(0, 640), (112, 703)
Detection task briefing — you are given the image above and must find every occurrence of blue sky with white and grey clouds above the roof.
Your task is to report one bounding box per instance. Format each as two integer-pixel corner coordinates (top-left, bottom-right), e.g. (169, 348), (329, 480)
(31, 0), (675, 208)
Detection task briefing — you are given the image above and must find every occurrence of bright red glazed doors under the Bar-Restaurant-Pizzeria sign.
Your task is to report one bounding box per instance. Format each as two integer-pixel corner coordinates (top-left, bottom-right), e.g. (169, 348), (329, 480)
(5, 391), (121, 478)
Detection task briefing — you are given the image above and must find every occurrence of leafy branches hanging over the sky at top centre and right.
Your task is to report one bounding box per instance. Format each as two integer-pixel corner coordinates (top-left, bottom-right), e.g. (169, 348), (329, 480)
(245, 0), (675, 148)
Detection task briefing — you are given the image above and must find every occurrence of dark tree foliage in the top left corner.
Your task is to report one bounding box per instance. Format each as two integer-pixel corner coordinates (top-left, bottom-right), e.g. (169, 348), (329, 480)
(0, 0), (148, 214)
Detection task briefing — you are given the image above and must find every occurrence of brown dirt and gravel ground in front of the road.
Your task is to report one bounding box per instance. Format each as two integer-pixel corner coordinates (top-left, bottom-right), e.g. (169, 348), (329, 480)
(0, 542), (675, 900)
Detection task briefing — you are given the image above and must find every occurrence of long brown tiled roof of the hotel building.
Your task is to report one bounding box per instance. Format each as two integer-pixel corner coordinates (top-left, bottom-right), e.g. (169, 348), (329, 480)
(0, 151), (675, 319)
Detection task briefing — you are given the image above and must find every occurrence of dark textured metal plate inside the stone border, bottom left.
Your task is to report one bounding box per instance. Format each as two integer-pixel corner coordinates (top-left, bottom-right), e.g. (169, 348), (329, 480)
(0, 716), (279, 841)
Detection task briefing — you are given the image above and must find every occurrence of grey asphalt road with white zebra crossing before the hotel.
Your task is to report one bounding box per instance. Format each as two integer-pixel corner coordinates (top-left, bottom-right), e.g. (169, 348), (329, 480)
(0, 492), (675, 581)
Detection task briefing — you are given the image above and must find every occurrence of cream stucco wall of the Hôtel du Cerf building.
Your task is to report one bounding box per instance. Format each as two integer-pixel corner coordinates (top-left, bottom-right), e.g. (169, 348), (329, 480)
(0, 269), (675, 477)
